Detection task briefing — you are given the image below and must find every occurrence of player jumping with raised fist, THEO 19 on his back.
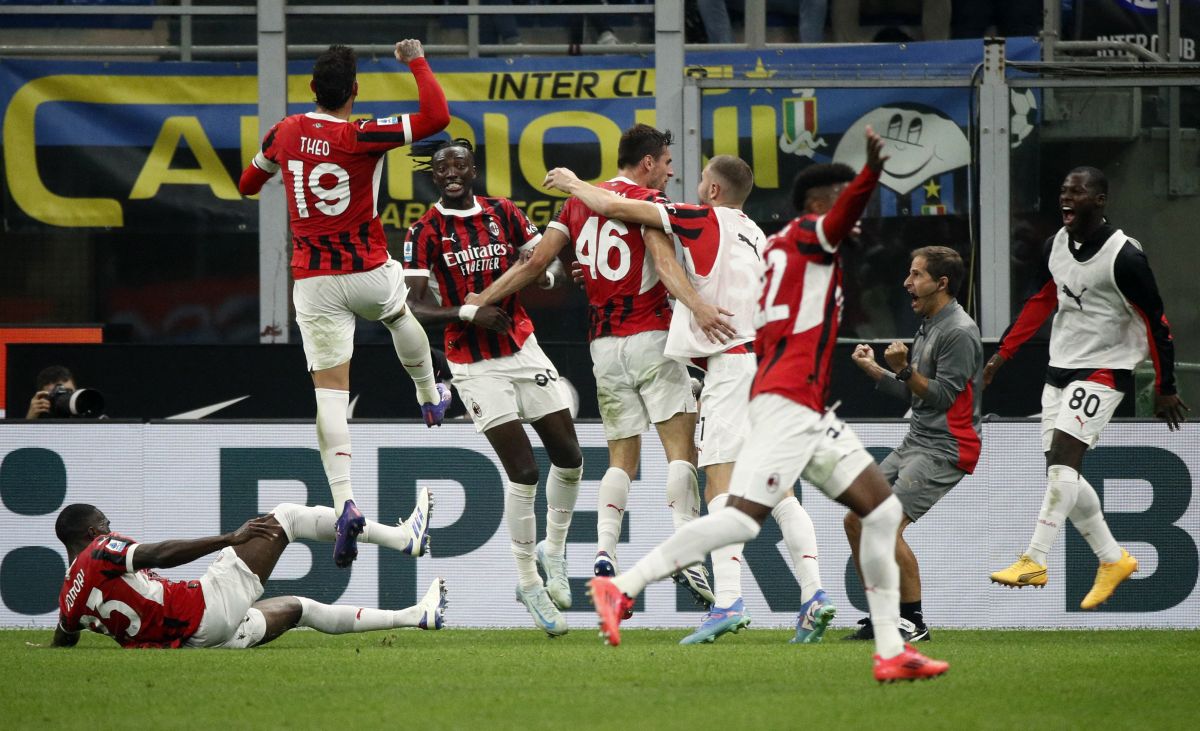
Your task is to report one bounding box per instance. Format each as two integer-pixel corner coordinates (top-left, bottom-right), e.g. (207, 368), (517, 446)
(238, 40), (450, 568)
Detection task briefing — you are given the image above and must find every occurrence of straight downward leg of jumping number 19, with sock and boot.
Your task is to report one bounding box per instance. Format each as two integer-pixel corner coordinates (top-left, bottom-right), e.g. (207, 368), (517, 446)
(312, 360), (366, 568)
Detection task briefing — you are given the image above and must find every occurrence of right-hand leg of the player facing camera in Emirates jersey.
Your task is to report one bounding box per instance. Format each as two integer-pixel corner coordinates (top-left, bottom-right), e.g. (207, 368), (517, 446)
(530, 409), (583, 610)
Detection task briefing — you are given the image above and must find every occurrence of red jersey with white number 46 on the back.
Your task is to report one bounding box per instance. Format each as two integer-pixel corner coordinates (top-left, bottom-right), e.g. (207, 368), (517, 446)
(550, 178), (671, 340)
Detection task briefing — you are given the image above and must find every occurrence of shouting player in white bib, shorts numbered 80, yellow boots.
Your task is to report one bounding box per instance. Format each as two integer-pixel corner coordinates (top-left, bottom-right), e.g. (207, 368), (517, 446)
(983, 167), (1188, 610)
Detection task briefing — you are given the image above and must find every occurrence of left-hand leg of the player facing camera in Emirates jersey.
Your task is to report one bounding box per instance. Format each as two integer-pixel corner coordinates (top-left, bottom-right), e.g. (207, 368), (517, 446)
(484, 419), (566, 636)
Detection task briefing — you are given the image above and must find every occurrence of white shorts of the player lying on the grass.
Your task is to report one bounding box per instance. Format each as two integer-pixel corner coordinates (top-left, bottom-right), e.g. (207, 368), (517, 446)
(185, 547), (266, 649)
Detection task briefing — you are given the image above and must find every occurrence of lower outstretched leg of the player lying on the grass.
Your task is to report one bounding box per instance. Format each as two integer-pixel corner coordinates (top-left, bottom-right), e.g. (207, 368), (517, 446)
(251, 579), (446, 647)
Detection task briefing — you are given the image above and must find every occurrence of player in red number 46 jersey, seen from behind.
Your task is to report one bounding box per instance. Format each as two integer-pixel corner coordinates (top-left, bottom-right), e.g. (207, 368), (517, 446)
(468, 124), (736, 610)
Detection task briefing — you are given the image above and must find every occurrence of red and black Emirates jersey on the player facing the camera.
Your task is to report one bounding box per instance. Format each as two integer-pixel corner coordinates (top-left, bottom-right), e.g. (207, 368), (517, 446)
(404, 196), (541, 362)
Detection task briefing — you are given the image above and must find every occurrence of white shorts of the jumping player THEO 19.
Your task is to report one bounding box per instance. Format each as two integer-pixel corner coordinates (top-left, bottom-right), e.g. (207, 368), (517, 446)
(292, 259), (408, 371)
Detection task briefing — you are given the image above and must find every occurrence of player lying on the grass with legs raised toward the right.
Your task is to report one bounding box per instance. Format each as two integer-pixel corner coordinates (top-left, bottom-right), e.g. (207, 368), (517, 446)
(53, 490), (446, 649)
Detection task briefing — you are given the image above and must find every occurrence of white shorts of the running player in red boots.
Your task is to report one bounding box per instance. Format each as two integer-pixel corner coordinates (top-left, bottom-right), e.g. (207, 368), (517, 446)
(730, 394), (875, 508)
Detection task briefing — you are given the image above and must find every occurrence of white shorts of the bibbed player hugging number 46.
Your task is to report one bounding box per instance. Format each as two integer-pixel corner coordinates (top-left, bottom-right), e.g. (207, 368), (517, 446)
(697, 353), (758, 467)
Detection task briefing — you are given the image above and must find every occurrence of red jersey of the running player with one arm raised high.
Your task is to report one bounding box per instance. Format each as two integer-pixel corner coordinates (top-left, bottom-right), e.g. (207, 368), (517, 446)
(750, 167), (880, 412)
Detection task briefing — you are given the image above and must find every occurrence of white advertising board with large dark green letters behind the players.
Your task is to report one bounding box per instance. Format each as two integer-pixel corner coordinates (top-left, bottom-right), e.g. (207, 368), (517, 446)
(0, 421), (1200, 629)
